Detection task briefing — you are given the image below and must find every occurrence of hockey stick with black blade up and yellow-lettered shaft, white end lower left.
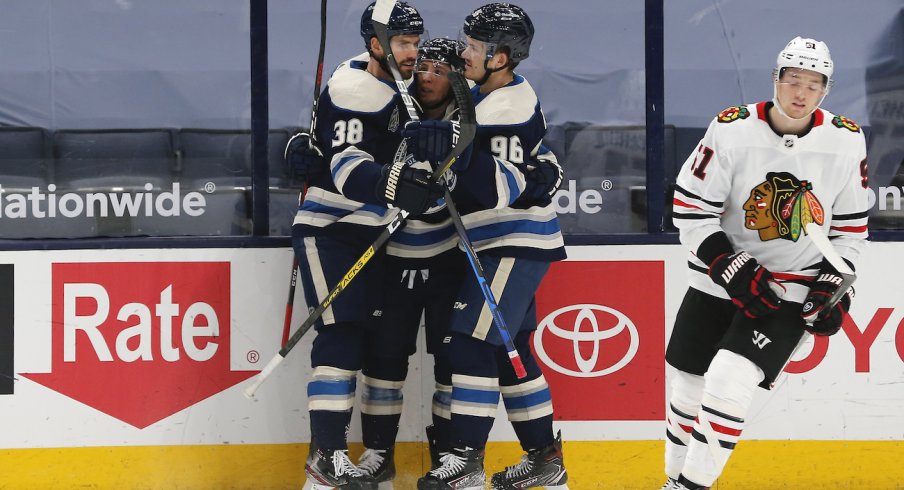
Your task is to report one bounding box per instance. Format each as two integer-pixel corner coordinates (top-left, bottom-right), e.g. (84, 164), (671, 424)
(244, 72), (477, 399)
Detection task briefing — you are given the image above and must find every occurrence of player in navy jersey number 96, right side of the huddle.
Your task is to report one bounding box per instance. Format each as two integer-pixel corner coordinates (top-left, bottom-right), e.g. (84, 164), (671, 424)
(418, 3), (567, 490)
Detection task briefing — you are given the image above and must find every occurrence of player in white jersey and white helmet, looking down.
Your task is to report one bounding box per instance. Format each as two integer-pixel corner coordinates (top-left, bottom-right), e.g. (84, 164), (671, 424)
(662, 37), (868, 489)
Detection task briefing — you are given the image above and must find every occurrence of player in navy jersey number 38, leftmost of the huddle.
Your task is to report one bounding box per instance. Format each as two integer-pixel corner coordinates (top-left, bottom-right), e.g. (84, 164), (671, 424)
(292, 2), (442, 490)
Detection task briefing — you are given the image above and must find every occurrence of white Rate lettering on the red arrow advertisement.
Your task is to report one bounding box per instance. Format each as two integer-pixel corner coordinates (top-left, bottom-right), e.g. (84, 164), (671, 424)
(63, 283), (220, 362)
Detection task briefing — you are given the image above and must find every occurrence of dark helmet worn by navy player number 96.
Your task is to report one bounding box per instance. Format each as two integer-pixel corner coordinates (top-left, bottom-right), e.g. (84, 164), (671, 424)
(464, 3), (534, 61)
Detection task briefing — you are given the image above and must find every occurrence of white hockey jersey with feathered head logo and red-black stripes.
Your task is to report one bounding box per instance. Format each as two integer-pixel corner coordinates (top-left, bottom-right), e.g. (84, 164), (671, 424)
(673, 102), (868, 302)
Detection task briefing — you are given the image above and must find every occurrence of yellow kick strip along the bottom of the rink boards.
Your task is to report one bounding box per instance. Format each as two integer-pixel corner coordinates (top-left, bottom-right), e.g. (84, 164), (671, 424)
(0, 440), (904, 490)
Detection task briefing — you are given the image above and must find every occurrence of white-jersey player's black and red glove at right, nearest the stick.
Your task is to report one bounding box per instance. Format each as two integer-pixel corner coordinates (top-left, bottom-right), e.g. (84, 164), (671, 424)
(800, 260), (854, 336)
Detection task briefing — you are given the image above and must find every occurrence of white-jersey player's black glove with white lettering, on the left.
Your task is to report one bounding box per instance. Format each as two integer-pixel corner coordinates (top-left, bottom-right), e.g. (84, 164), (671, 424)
(709, 251), (782, 318)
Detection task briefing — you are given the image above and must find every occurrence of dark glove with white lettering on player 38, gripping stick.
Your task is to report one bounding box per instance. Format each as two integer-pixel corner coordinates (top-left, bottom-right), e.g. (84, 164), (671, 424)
(376, 162), (443, 216)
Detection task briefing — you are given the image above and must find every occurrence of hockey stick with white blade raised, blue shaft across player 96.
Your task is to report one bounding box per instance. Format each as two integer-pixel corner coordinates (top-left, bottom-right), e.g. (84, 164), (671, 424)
(372, 0), (527, 379)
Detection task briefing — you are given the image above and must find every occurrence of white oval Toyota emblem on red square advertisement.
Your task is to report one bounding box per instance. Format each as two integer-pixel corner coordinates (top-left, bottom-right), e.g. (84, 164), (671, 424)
(534, 304), (640, 378)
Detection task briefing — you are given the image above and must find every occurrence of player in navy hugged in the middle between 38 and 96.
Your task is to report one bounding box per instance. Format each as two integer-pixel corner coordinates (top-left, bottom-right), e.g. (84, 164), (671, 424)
(358, 38), (468, 482)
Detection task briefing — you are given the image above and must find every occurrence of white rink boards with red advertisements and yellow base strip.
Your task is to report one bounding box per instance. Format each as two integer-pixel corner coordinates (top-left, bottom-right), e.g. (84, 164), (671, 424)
(0, 243), (904, 489)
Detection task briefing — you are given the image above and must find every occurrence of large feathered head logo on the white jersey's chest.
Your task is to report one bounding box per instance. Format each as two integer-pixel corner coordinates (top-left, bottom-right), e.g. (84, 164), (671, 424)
(744, 172), (825, 242)
